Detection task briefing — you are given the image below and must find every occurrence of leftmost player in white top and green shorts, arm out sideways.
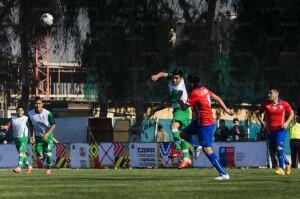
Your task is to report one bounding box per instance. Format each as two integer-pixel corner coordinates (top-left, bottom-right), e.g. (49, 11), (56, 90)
(0, 106), (32, 173)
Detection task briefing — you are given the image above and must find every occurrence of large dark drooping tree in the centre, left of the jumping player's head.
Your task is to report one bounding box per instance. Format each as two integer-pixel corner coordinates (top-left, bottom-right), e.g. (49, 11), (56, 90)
(83, 0), (172, 130)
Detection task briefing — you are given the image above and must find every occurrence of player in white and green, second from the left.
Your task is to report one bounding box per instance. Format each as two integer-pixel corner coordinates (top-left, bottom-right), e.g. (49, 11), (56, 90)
(28, 97), (56, 175)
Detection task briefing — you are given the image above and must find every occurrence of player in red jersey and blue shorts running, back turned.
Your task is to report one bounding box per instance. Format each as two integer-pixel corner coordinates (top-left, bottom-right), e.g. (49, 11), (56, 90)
(181, 77), (233, 180)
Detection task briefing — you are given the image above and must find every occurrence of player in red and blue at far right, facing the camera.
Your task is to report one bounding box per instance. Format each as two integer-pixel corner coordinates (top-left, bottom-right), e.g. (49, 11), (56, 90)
(257, 88), (294, 175)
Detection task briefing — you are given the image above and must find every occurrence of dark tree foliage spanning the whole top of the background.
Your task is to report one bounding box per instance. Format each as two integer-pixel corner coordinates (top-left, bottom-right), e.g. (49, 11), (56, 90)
(0, 0), (300, 110)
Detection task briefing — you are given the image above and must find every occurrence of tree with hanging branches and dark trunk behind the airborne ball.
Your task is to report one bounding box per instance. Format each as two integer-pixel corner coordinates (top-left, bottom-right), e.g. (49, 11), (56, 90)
(0, 0), (81, 109)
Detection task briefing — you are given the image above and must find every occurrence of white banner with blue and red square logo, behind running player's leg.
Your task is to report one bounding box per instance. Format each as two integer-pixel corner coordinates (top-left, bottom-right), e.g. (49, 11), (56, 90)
(193, 142), (267, 167)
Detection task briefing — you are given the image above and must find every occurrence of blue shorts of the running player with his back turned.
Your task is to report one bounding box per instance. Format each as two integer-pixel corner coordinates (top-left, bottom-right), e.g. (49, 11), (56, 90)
(182, 120), (215, 147)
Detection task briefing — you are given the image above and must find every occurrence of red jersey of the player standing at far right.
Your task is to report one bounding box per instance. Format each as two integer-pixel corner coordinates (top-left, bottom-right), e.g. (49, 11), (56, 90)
(259, 100), (292, 132)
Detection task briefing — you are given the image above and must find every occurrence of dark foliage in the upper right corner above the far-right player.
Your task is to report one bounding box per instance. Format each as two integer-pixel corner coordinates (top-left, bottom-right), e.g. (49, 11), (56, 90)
(231, 0), (300, 104)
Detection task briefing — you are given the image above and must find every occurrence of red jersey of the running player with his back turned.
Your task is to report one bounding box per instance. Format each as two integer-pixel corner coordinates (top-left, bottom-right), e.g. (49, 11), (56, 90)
(188, 87), (215, 126)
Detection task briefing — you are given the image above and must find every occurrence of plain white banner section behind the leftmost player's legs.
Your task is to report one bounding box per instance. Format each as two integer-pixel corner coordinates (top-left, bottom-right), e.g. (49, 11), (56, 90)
(0, 144), (32, 168)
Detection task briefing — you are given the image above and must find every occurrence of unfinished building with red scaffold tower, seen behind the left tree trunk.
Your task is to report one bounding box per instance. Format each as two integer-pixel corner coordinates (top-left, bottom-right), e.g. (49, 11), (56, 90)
(0, 34), (98, 117)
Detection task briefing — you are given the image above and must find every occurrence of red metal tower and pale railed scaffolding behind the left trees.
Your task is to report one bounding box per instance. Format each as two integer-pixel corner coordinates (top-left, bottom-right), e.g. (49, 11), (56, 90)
(34, 32), (98, 101)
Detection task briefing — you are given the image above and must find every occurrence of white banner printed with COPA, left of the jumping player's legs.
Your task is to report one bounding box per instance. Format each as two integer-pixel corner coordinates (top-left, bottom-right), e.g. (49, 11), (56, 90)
(129, 143), (158, 167)
